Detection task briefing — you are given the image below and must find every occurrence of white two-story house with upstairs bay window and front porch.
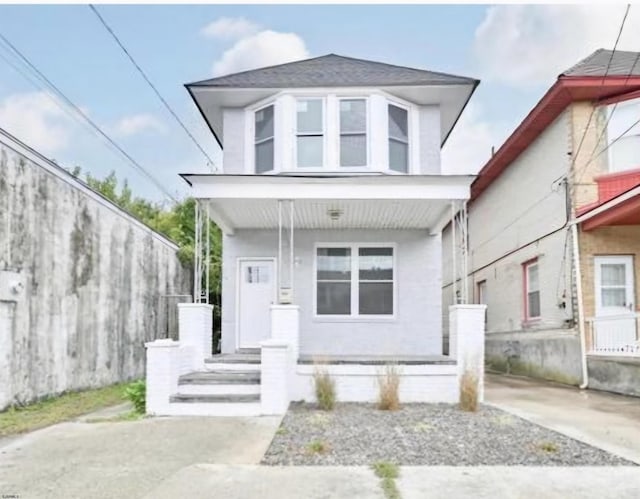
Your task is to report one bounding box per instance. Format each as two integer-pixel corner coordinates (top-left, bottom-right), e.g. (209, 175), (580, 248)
(144, 54), (483, 415)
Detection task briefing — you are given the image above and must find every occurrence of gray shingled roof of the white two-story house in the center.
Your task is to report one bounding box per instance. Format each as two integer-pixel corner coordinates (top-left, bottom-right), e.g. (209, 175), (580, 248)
(187, 54), (477, 88)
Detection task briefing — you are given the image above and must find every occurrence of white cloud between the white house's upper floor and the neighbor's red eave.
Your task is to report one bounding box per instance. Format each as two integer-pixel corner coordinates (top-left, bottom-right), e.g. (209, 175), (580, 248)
(442, 103), (497, 175)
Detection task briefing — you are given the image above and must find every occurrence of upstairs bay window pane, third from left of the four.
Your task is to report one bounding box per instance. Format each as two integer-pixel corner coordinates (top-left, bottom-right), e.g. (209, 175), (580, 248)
(340, 99), (367, 166)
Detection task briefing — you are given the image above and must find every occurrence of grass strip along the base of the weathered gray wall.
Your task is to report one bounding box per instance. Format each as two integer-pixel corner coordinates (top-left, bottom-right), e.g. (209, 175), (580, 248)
(0, 383), (127, 437)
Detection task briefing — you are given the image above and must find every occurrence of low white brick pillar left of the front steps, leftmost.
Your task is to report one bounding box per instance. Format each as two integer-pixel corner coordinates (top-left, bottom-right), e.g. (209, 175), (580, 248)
(144, 339), (180, 416)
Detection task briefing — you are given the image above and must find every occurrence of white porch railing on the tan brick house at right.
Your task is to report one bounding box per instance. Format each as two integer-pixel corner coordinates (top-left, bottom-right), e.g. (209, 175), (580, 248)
(586, 313), (640, 357)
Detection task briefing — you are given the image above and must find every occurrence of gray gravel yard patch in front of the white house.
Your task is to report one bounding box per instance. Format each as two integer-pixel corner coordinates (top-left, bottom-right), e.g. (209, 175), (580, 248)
(262, 403), (633, 466)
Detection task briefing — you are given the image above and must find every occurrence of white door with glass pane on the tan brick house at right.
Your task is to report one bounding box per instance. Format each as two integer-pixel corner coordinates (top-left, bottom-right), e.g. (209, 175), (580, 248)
(594, 256), (636, 353)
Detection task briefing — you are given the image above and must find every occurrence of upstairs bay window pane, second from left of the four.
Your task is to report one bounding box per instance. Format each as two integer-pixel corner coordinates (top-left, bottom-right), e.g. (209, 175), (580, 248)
(296, 99), (324, 168)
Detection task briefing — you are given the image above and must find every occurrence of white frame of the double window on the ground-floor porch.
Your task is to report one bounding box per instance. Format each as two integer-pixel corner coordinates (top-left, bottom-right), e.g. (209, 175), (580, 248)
(312, 242), (398, 322)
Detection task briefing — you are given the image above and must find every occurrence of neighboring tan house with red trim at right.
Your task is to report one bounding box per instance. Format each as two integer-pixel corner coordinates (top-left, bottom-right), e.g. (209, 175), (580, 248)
(443, 50), (640, 395)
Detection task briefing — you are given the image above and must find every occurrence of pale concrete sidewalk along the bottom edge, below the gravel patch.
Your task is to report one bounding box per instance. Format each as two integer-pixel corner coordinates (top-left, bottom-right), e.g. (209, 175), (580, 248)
(145, 464), (640, 499)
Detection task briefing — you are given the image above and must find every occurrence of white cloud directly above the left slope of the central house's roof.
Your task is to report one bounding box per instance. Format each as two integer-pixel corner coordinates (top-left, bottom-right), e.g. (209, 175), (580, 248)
(213, 30), (309, 76)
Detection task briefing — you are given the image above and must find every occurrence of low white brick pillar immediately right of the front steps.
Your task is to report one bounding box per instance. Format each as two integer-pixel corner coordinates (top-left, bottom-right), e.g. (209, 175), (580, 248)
(260, 339), (291, 415)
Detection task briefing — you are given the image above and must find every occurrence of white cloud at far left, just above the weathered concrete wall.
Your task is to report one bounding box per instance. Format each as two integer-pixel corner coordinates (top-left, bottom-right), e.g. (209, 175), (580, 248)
(0, 92), (73, 155)
